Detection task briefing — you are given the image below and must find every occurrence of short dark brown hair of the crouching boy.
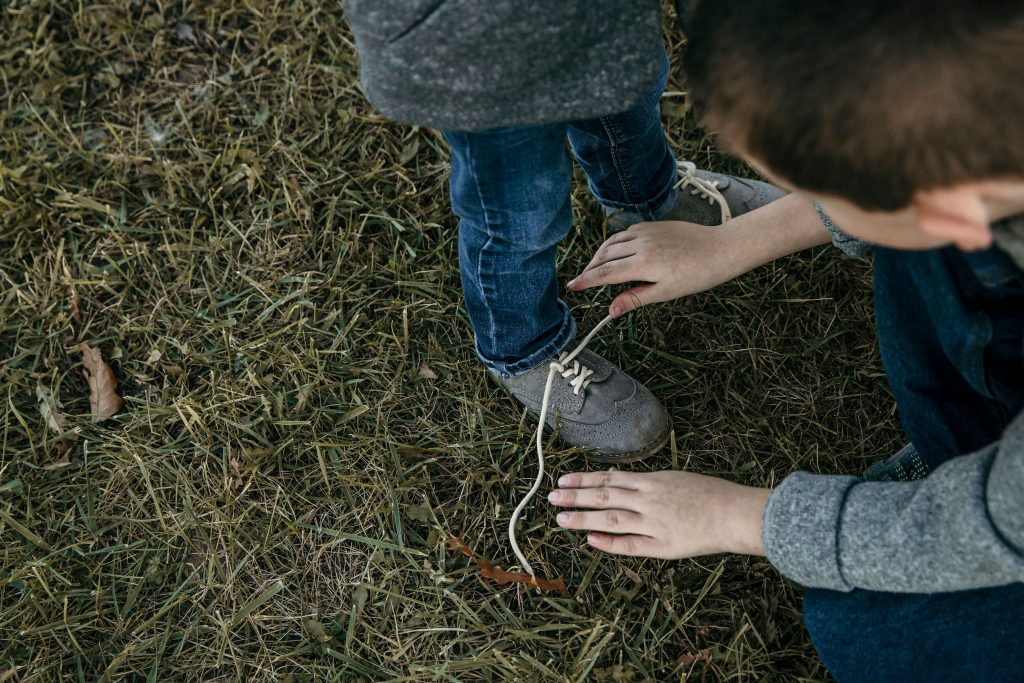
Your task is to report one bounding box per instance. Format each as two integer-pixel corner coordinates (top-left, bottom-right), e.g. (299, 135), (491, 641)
(686, 0), (1024, 211)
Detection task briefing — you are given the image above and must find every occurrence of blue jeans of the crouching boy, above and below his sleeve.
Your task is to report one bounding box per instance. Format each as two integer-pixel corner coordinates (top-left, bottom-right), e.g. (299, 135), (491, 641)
(804, 242), (1024, 683)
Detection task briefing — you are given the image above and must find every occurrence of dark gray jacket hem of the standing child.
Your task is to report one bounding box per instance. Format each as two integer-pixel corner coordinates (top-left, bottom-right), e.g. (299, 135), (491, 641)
(342, 0), (665, 130)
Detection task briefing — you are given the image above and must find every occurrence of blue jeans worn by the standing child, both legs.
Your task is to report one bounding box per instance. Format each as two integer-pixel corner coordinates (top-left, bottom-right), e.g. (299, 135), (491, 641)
(444, 54), (676, 377)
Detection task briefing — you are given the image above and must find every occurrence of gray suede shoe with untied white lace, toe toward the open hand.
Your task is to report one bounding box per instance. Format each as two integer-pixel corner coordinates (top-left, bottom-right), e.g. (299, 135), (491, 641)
(495, 349), (672, 463)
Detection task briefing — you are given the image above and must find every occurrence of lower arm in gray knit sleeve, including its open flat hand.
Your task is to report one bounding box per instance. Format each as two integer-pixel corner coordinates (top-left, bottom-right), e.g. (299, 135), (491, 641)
(549, 413), (1024, 593)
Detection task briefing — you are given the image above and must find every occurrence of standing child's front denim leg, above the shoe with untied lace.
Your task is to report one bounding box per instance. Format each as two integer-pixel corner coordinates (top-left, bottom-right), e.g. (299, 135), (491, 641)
(444, 124), (575, 377)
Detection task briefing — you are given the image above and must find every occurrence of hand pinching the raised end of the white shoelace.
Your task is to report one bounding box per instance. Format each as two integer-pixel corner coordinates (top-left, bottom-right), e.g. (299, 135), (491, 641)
(568, 221), (739, 317)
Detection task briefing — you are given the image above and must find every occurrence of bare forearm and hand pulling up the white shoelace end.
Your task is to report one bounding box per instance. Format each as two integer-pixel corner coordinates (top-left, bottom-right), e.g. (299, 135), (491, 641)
(568, 195), (831, 316)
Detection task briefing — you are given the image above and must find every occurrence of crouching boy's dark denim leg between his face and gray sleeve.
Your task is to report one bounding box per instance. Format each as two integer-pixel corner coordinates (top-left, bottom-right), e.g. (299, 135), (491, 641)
(873, 247), (1024, 471)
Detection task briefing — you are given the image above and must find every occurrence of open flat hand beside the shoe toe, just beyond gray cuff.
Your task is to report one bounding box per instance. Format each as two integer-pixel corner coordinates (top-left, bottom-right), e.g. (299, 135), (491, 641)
(548, 470), (771, 559)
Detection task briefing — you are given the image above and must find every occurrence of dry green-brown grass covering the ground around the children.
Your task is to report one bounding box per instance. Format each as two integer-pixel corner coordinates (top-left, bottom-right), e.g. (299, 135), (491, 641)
(0, 0), (899, 683)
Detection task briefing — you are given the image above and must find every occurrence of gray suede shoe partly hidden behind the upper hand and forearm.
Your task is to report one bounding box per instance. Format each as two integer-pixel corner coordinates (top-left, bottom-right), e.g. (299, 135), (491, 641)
(608, 161), (785, 231)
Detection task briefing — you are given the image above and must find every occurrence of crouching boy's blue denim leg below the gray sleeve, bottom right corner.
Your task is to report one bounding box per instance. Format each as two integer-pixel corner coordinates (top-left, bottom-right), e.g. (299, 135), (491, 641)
(804, 584), (1024, 683)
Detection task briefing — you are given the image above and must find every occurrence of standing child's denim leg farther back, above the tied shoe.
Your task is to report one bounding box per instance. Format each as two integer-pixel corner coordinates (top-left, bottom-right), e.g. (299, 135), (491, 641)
(568, 51), (676, 220)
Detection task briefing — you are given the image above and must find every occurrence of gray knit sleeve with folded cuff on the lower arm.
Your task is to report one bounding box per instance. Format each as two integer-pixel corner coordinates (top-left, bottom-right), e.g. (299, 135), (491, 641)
(762, 414), (1024, 593)
